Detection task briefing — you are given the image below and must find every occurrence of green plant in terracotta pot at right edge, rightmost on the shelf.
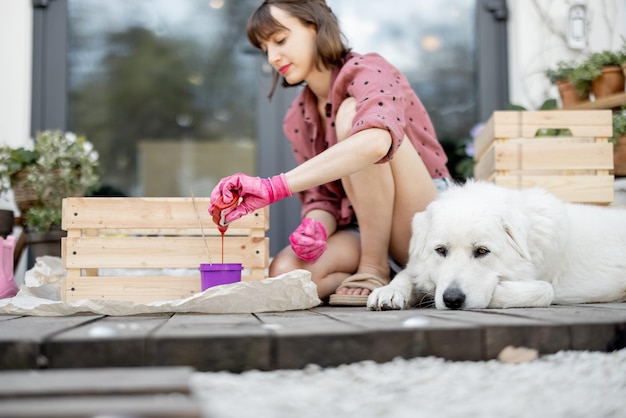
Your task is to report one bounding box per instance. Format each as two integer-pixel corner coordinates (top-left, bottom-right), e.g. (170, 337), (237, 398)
(570, 51), (626, 99)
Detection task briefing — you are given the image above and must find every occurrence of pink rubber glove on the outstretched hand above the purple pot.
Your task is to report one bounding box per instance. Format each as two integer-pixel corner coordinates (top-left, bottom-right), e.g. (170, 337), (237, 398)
(209, 173), (292, 224)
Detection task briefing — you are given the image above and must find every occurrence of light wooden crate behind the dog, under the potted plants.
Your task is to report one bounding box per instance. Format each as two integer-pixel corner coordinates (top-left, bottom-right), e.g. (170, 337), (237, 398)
(474, 110), (614, 204)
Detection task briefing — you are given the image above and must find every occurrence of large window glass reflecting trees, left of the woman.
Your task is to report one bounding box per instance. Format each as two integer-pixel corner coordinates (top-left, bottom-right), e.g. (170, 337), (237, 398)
(68, 0), (258, 196)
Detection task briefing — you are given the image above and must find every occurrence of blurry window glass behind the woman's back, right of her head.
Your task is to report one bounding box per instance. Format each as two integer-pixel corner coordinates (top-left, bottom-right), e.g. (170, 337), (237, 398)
(328, 0), (477, 149)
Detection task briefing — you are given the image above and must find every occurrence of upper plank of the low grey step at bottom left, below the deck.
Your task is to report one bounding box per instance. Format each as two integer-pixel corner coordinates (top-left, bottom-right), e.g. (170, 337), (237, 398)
(0, 367), (194, 399)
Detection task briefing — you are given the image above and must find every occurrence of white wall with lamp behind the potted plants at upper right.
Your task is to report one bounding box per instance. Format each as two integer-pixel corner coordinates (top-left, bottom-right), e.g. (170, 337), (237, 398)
(508, 0), (626, 109)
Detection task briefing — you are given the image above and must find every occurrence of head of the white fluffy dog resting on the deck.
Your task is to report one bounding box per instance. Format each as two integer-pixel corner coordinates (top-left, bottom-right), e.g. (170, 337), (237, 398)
(410, 184), (534, 309)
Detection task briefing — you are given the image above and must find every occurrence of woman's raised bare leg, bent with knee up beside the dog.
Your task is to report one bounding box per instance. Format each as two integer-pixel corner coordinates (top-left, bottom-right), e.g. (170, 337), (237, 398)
(336, 99), (437, 295)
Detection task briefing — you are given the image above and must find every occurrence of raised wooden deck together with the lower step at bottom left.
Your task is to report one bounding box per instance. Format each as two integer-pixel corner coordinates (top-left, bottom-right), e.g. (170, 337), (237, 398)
(0, 303), (626, 418)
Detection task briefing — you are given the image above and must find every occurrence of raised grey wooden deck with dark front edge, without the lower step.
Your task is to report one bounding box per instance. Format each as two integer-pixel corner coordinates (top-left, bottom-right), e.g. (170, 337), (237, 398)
(0, 303), (626, 372)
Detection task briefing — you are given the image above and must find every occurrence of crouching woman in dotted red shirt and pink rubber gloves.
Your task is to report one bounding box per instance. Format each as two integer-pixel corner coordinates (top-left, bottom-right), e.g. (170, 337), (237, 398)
(210, 0), (449, 306)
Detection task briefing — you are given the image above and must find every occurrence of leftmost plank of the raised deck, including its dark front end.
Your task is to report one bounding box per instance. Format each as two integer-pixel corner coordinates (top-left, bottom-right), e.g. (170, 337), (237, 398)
(0, 315), (101, 369)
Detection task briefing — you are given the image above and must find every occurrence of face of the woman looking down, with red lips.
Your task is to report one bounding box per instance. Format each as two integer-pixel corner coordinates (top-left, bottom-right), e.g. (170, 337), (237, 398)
(261, 6), (319, 84)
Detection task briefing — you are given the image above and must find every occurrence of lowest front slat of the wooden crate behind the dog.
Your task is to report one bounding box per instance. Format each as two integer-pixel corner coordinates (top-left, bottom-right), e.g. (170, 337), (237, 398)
(495, 175), (615, 204)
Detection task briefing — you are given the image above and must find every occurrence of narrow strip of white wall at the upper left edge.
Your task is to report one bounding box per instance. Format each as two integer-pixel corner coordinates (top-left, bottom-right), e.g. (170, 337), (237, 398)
(0, 0), (33, 149)
